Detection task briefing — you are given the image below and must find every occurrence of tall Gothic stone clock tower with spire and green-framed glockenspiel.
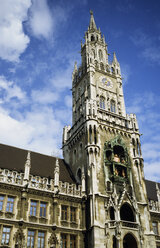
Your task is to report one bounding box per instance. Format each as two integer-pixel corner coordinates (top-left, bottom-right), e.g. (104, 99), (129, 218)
(63, 12), (156, 248)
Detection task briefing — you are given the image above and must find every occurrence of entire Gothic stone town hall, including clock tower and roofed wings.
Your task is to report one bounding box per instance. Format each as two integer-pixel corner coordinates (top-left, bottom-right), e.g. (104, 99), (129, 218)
(0, 12), (160, 248)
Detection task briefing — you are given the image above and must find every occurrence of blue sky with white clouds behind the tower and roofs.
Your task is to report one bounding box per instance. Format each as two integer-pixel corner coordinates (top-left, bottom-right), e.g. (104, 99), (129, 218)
(0, 0), (160, 181)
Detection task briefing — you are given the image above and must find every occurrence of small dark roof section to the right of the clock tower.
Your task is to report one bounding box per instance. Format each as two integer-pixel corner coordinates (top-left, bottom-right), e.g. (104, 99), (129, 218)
(145, 180), (160, 201)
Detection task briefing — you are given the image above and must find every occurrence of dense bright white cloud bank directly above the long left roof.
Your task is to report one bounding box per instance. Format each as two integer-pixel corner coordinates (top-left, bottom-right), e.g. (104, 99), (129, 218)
(0, 103), (63, 156)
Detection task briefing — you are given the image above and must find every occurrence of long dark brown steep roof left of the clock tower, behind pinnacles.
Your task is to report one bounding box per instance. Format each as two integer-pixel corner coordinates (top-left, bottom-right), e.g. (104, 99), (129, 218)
(0, 144), (75, 183)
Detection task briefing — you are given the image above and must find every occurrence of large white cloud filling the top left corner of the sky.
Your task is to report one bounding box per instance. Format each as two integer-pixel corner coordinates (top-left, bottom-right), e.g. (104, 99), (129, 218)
(0, 0), (31, 62)
